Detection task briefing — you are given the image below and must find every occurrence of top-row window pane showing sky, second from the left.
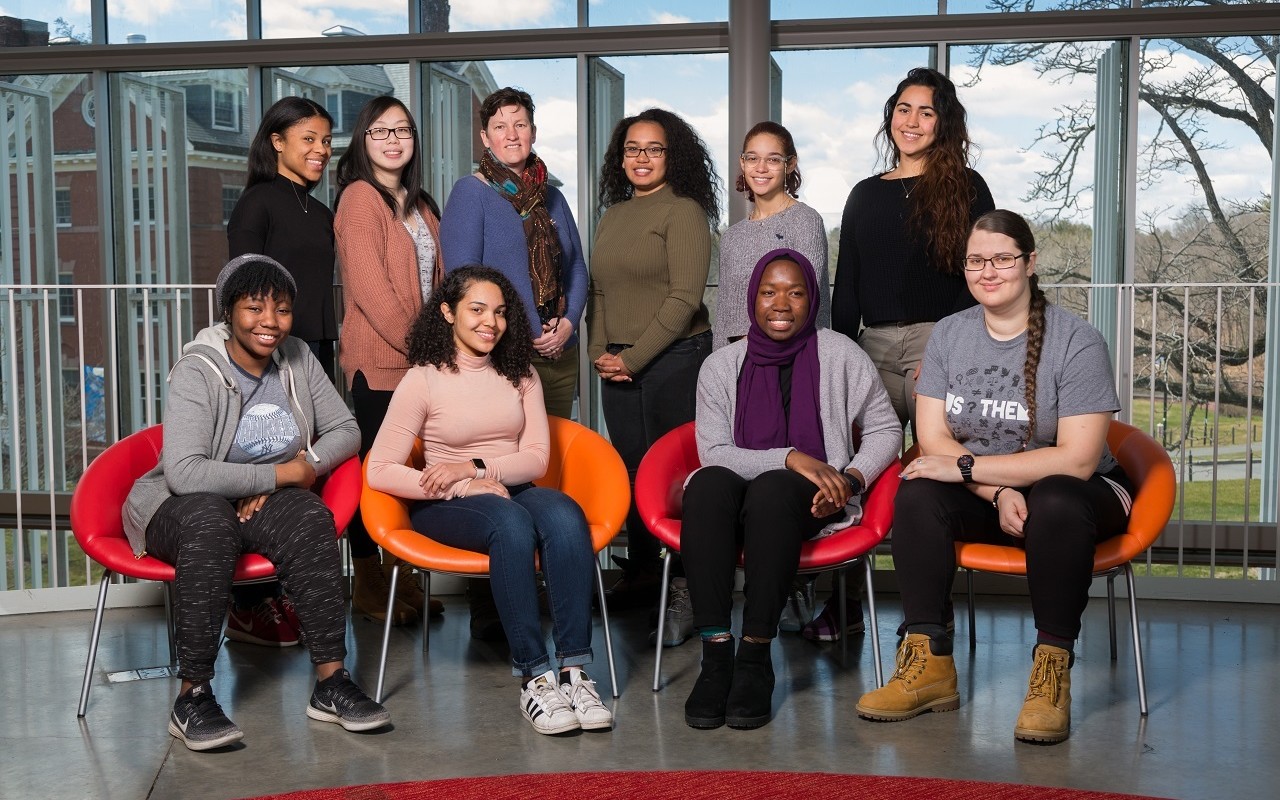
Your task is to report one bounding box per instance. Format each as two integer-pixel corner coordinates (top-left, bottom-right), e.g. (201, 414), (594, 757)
(106, 0), (244, 45)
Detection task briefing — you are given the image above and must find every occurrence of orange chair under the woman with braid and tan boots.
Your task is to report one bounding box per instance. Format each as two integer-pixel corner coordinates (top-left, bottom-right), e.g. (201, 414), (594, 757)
(956, 420), (1176, 717)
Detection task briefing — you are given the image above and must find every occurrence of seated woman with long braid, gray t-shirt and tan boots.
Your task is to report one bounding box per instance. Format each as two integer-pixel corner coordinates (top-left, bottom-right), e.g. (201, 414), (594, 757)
(858, 210), (1132, 742)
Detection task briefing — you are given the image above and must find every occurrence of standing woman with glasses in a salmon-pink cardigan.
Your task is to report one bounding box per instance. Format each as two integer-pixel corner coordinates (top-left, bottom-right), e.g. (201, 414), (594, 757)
(334, 96), (444, 625)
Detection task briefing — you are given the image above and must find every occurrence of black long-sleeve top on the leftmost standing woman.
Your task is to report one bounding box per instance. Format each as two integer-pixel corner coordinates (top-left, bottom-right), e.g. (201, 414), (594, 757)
(227, 174), (338, 342)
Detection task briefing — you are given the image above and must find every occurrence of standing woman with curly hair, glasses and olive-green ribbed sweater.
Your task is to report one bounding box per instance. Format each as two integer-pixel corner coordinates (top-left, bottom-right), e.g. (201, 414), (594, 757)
(586, 109), (719, 614)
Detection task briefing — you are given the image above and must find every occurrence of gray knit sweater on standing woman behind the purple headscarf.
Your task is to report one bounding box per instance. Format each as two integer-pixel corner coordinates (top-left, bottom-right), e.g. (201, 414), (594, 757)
(712, 202), (831, 351)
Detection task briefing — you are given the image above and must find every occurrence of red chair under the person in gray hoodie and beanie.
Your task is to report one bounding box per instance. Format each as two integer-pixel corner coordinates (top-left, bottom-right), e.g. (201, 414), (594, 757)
(72, 425), (360, 717)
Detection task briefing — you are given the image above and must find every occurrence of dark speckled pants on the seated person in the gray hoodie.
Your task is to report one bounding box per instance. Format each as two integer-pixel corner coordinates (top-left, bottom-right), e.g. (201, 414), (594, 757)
(147, 488), (347, 684)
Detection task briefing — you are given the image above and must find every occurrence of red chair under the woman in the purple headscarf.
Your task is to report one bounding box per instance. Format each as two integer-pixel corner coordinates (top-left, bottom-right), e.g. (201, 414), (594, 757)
(636, 422), (901, 691)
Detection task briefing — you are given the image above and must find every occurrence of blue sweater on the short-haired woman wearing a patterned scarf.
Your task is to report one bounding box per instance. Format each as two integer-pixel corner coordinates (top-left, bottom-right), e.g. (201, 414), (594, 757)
(440, 175), (588, 344)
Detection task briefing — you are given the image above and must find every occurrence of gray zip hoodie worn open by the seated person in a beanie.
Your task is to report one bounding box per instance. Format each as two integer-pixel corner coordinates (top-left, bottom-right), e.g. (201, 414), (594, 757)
(124, 323), (360, 556)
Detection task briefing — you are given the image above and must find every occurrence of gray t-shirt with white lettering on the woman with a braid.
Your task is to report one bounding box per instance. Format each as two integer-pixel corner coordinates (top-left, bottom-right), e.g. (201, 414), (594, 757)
(915, 305), (1120, 472)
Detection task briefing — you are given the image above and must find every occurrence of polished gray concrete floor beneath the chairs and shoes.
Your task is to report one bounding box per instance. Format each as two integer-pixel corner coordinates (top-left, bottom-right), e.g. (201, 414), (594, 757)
(0, 586), (1280, 800)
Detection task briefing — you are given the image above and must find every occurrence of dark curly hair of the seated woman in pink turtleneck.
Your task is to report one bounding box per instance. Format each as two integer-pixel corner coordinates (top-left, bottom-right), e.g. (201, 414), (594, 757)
(404, 264), (534, 389)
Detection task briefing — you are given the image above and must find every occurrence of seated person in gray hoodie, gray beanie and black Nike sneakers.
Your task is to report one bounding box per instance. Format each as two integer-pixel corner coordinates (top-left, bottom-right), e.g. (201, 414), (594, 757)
(124, 253), (390, 750)
